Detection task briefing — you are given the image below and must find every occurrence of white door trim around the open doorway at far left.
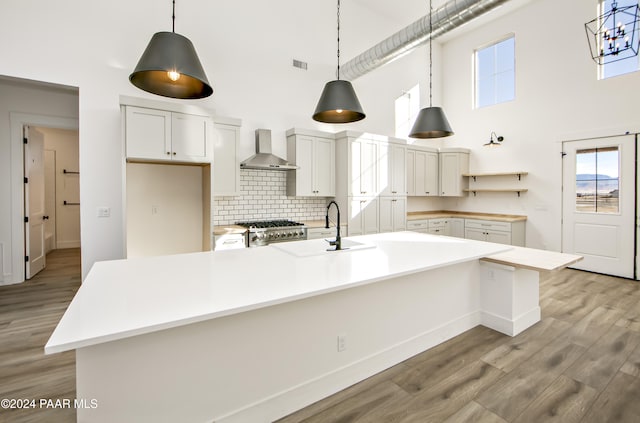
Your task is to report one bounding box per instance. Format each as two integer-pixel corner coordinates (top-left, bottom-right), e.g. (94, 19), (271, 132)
(9, 112), (80, 284)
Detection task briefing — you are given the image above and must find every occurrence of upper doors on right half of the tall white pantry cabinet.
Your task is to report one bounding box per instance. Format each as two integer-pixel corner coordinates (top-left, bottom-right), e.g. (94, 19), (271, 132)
(378, 142), (407, 196)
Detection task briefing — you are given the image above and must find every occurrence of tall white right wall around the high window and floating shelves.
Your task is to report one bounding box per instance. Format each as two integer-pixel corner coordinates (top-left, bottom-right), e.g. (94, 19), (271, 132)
(442, 0), (640, 250)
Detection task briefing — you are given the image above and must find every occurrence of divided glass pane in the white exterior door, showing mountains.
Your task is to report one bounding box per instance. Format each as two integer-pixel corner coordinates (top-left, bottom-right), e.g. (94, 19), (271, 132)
(576, 147), (620, 213)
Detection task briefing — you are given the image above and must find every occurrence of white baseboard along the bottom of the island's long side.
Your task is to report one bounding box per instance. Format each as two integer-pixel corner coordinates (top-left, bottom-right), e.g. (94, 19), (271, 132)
(213, 311), (482, 423)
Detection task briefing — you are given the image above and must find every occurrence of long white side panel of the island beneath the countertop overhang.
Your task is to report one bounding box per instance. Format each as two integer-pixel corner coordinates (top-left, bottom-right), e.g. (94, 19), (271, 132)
(76, 260), (481, 422)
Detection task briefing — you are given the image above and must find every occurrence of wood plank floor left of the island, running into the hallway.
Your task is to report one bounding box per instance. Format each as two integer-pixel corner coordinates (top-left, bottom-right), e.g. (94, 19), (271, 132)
(0, 248), (81, 423)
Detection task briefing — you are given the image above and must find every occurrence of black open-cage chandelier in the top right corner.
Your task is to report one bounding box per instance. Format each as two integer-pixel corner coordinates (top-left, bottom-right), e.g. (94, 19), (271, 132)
(584, 1), (640, 65)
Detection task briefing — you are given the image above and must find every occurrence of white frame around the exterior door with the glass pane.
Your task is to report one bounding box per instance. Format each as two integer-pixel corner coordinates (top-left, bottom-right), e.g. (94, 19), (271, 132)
(560, 131), (640, 280)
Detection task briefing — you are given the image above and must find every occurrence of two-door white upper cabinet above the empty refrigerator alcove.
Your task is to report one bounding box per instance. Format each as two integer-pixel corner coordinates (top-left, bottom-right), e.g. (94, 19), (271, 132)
(125, 106), (213, 163)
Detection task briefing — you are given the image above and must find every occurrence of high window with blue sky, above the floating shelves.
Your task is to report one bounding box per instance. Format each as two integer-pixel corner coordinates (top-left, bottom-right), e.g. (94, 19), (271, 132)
(474, 36), (516, 108)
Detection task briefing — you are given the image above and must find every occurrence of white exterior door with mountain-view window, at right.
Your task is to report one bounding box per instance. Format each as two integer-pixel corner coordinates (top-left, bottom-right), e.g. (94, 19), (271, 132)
(562, 135), (636, 278)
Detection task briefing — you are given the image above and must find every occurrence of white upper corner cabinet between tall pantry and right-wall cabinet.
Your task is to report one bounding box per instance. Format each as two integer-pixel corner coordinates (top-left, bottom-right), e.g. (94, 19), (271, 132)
(407, 146), (439, 197)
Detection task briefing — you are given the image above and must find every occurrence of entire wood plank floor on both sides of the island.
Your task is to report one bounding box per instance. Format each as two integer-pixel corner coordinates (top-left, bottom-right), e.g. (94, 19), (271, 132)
(0, 250), (640, 423)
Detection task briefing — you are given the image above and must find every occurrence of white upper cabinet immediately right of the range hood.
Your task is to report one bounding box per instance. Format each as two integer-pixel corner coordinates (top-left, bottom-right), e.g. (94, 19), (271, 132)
(287, 129), (336, 197)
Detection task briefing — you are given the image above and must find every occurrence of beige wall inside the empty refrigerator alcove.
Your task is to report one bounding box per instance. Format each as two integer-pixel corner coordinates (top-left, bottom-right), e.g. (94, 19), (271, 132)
(126, 163), (204, 258)
